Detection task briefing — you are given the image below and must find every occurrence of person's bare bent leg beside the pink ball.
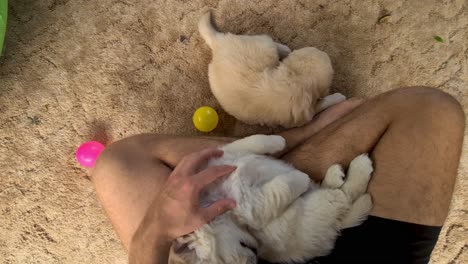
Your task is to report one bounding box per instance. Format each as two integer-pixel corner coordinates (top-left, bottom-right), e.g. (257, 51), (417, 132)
(91, 134), (231, 249)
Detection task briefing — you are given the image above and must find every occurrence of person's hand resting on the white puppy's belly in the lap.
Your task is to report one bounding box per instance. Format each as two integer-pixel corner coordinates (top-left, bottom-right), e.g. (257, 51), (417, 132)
(136, 149), (236, 241)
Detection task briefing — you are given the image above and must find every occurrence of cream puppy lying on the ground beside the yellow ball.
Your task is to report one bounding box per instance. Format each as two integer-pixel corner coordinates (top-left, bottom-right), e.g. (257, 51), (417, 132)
(198, 13), (345, 127)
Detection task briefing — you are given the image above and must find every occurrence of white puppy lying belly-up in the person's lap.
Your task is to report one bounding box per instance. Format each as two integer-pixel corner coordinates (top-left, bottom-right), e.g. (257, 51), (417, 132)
(173, 135), (373, 264)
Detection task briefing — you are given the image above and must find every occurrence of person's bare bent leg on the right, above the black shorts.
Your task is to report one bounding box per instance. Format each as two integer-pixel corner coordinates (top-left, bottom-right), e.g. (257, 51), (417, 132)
(283, 87), (464, 226)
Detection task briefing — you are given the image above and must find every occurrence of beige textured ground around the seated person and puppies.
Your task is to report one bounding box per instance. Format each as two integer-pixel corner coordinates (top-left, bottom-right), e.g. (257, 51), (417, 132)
(0, 0), (468, 263)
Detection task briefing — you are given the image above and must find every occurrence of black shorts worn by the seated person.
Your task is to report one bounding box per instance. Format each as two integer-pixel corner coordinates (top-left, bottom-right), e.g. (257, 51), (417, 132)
(259, 216), (441, 264)
